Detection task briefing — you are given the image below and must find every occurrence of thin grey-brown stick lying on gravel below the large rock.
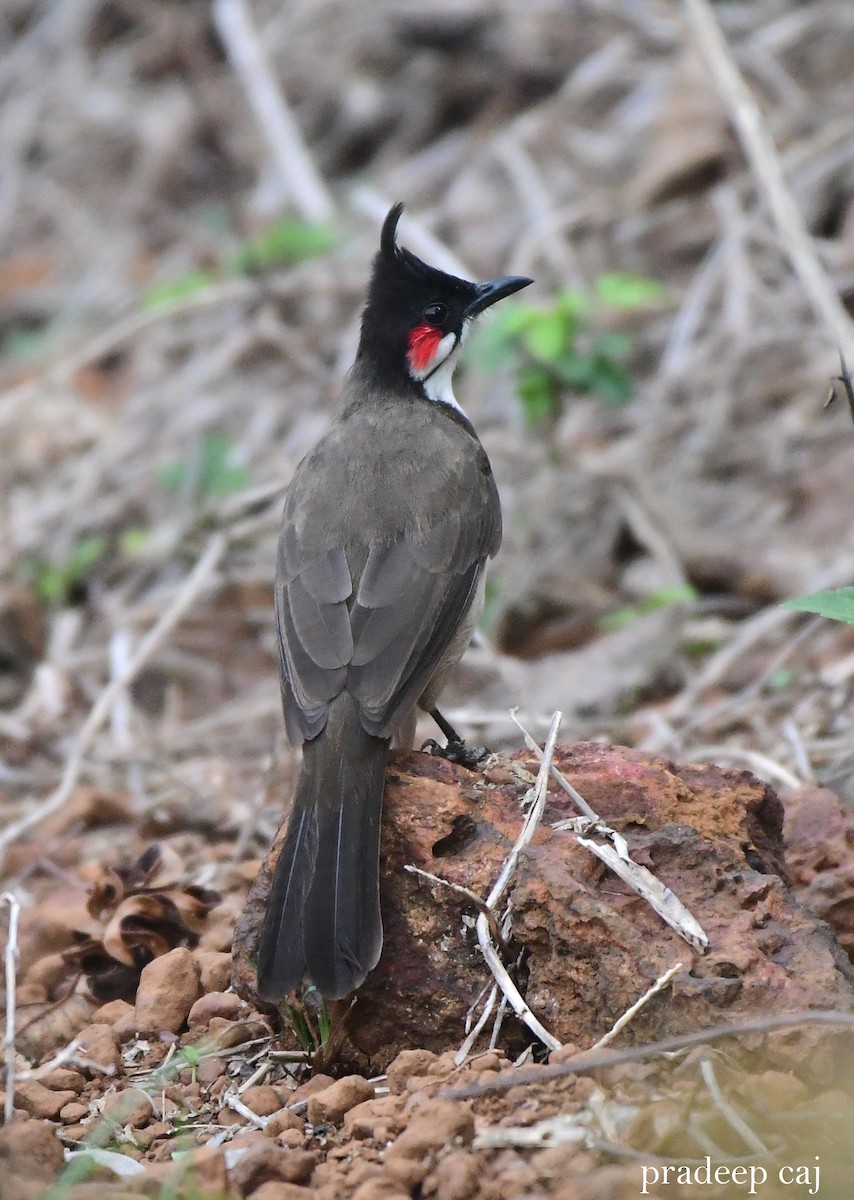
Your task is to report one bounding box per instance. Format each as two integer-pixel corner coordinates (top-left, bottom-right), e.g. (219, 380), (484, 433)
(439, 1008), (854, 1100)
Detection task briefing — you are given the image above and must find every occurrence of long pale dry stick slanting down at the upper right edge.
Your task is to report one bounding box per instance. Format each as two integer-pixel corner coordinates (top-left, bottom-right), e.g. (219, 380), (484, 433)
(684, 0), (854, 362)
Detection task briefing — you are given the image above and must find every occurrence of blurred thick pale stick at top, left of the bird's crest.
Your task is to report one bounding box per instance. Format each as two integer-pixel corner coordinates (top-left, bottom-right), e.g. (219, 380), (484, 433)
(214, 0), (335, 222)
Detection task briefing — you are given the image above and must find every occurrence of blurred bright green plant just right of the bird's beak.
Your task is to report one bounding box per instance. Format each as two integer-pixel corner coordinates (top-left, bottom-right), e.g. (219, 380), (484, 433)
(473, 274), (667, 428)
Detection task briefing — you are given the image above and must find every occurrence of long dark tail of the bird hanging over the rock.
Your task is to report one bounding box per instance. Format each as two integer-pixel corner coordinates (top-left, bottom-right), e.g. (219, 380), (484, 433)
(258, 694), (389, 1001)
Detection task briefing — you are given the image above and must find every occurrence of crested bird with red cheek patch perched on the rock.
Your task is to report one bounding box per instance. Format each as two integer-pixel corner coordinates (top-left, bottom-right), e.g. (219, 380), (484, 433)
(257, 204), (533, 1002)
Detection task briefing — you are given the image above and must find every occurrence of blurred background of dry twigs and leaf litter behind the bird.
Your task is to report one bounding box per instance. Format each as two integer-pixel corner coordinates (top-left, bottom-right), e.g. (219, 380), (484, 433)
(0, 0), (854, 850)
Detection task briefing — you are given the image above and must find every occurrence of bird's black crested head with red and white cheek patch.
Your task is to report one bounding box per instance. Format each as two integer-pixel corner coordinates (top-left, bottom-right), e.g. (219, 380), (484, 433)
(359, 204), (533, 407)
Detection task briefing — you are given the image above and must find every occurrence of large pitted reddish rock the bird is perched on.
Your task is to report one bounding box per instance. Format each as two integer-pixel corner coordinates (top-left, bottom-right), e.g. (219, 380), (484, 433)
(234, 744), (854, 1086)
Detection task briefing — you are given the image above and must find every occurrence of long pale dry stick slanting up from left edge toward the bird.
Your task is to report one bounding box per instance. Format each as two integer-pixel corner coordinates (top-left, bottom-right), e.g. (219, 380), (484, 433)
(0, 533), (228, 866)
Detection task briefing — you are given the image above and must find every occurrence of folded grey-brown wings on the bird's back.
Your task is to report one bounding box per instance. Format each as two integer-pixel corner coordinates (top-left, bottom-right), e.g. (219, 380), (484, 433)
(276, 417), (500, 742)
